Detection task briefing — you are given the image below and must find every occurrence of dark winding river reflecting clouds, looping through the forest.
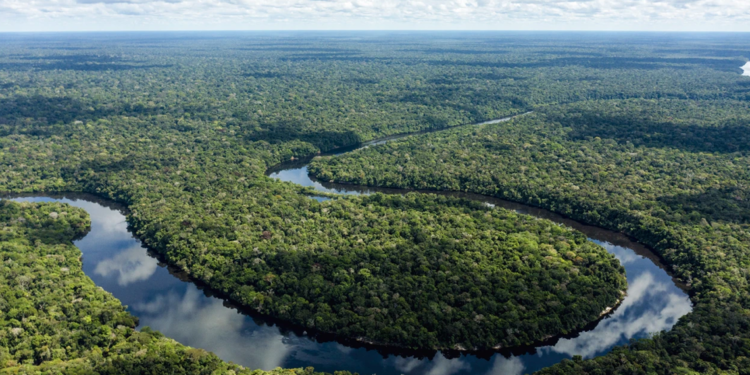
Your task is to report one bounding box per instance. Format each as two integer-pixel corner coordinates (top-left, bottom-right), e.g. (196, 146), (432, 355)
(8, 114), (692, 375)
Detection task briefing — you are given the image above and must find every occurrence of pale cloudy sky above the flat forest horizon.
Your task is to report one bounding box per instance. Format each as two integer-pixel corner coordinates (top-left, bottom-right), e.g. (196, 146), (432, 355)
(0, 0), (750, 32)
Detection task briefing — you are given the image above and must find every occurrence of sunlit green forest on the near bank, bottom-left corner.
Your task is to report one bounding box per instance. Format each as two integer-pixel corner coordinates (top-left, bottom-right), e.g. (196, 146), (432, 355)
(0, 201), (346, 375)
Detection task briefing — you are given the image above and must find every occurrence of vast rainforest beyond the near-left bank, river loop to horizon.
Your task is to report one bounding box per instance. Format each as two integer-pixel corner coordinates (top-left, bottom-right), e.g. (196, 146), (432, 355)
(0, 33), (750, 373)
